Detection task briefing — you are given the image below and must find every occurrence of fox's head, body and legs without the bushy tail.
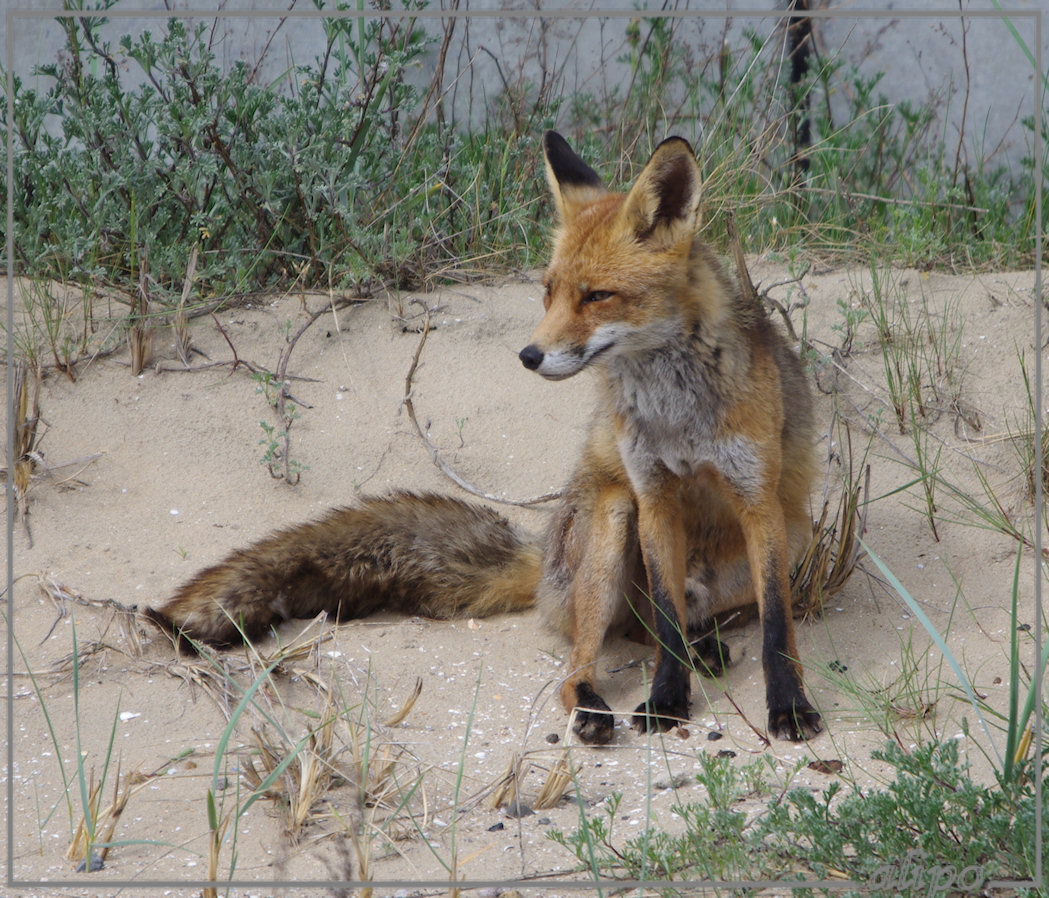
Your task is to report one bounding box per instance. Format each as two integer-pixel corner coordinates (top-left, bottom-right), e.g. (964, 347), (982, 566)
(521, 129), (820, 743)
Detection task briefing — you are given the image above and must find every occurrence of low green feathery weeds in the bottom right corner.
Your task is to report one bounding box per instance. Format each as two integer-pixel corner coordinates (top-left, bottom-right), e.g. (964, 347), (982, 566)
(549, 740), (1035, 896)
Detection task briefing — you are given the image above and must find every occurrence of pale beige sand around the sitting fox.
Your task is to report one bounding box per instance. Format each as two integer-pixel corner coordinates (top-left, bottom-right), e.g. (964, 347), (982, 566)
(5, 258), (1035, 896)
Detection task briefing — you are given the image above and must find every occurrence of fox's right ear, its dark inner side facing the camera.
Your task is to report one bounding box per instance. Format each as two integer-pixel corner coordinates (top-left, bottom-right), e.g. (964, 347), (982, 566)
(620, 137), (703, 248)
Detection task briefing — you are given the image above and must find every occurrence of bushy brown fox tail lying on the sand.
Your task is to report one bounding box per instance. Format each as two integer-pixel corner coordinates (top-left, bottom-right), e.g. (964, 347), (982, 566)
(146, 493), (542, 645)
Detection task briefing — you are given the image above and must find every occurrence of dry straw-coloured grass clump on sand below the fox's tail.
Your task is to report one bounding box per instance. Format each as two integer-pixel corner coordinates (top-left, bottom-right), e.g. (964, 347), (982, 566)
(186, 632), (438, 895)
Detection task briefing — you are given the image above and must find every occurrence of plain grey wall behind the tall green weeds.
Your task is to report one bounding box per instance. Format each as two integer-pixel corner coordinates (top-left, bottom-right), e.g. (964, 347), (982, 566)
(0, 0), (1049, 194)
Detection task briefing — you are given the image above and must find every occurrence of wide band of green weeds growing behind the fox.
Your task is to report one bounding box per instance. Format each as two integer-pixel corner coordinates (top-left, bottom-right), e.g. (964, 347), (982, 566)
(6, 0), (1030, 325)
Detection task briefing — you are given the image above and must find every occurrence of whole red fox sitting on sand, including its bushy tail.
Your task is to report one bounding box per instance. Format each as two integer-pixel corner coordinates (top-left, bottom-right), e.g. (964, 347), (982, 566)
(147, 131), (821, 744)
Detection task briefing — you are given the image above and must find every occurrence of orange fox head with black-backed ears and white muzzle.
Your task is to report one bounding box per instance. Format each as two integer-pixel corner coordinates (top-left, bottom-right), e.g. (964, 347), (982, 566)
(520, 131), (702, 380)
